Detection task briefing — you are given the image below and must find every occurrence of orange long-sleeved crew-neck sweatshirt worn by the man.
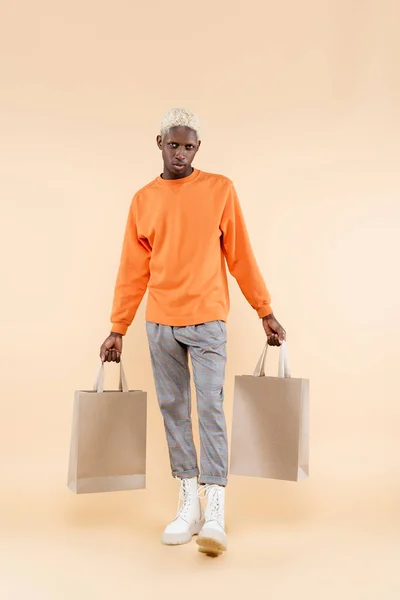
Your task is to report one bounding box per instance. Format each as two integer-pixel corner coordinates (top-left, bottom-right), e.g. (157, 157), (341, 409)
(111, 169), (272, 335)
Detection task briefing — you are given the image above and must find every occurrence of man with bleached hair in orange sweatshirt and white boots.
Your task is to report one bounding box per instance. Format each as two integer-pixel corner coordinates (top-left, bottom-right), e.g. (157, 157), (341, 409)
(100, 109), (286, 553)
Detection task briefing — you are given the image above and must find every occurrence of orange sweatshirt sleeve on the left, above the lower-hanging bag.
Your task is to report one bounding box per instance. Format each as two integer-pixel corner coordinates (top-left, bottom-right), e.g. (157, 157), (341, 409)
(111, 197), (151, 335)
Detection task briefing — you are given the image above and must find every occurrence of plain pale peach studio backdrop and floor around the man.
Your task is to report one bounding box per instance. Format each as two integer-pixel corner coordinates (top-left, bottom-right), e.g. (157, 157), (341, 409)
(0, 0), (400, 600)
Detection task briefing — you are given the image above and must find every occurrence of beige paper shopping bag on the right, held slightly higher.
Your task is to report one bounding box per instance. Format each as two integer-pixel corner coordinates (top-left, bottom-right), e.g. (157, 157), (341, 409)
(230, 343), (309, 481)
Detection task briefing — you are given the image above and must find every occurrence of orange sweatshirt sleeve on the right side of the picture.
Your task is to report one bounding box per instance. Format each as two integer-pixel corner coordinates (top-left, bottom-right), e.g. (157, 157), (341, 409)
(221, 182), (272, 319)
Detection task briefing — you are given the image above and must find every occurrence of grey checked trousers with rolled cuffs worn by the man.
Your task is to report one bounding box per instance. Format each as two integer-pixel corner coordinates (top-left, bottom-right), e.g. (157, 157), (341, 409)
(146, 321), (228, 485)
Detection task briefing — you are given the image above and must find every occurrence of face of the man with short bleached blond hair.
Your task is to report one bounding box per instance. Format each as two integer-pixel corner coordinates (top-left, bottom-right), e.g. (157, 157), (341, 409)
(157, 127), (200, 179)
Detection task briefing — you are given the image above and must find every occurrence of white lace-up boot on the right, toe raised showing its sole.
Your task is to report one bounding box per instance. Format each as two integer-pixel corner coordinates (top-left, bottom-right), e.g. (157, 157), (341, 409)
(196, 485), (228, 554)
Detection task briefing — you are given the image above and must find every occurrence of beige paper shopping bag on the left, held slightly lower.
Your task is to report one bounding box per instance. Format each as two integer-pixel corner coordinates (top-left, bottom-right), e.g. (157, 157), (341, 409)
(68, 364), (147, 494)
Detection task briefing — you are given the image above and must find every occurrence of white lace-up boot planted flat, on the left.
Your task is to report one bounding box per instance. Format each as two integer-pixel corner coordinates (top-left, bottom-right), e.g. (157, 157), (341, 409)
(161, 477), (204, 545)
